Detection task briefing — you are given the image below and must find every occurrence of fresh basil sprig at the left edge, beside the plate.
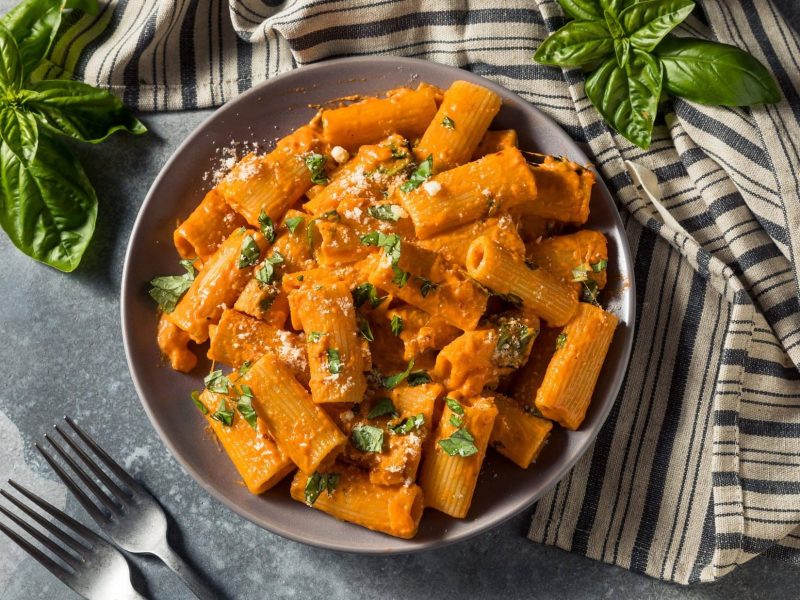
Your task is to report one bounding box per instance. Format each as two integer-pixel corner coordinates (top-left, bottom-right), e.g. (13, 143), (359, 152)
(0, 0), (146, 271)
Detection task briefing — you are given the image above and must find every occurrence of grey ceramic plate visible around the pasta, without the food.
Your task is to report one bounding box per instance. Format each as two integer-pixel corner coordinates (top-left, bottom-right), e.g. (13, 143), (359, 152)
(122, 57), (635, 553)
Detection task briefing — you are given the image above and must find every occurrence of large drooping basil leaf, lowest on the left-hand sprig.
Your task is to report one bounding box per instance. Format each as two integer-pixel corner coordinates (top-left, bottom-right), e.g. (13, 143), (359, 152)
(0, 131), (97, 272)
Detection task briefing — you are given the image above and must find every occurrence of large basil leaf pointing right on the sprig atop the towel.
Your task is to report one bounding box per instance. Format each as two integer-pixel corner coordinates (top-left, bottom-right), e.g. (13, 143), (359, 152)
(655, 36), (781, 106)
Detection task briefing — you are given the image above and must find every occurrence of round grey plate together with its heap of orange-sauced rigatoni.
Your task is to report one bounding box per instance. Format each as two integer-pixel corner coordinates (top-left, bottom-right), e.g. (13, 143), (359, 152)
(122, 57), (635, 553)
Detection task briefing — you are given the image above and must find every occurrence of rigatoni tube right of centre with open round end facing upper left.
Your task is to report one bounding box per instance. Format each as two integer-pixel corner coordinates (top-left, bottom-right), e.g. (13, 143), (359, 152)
(467, 237), (578, 325)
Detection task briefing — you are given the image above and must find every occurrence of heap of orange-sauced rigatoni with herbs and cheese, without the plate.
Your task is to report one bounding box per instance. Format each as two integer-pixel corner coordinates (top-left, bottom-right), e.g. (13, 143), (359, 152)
(151, 81), (617, 538)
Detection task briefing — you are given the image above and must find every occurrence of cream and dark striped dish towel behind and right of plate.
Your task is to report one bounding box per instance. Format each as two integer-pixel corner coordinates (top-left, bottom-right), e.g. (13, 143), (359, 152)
(47, 0), (800, 583)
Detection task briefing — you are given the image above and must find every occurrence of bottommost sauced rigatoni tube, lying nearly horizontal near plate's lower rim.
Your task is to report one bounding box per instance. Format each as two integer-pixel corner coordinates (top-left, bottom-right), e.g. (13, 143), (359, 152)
(291, 465), (423, 539)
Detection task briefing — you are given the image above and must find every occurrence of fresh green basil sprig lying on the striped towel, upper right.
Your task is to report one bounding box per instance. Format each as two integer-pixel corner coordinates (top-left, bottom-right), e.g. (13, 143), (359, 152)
(534, 0), (781, 149)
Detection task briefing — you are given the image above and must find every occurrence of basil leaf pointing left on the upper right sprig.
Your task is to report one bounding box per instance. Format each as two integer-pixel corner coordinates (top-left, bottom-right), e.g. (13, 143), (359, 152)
(533, 21), (614, 67)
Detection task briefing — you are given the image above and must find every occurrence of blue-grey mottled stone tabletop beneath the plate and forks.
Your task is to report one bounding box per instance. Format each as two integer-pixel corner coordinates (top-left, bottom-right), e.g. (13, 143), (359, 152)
(0, 0), (800, 600)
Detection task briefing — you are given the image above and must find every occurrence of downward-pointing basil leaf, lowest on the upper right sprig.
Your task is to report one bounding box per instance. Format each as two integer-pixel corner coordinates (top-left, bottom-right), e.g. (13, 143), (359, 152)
(586, 49), (663, 150)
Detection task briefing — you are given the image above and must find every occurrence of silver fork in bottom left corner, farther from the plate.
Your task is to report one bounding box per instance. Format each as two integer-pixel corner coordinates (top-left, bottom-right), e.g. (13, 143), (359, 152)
(0, 480), (145, 600)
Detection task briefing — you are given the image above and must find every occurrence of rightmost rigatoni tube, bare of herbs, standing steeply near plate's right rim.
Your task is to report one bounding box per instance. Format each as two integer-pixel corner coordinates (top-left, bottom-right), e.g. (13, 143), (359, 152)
(536, 302), (618, 430)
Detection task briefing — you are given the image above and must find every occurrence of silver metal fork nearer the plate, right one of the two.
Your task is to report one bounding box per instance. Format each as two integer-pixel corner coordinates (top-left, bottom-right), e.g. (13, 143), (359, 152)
(35, 416), (217, 600)
